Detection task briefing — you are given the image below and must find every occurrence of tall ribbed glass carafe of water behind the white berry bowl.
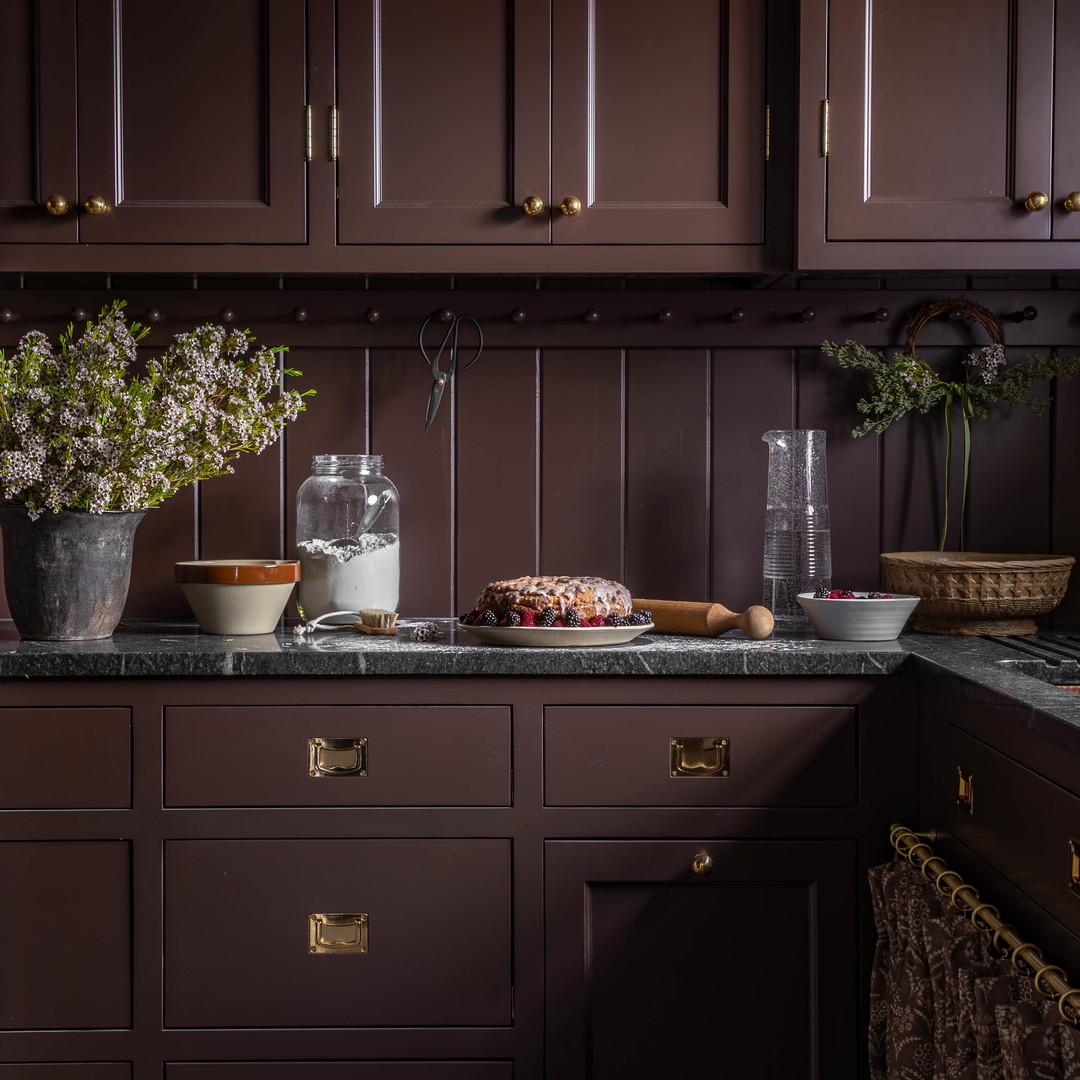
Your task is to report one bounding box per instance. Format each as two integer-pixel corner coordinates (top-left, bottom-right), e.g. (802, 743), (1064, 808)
(761, 430), (833, 632)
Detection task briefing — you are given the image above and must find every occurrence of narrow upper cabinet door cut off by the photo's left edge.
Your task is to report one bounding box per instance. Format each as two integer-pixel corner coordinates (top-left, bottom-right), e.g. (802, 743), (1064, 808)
(0, 0), (78, 244)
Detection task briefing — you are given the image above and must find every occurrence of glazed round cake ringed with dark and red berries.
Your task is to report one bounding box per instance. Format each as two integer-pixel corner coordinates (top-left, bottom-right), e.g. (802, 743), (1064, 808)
(461, 577), (652, 626)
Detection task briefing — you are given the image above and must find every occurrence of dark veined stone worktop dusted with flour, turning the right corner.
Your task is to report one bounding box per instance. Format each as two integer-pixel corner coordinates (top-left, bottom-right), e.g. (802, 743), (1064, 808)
(6, 619), (1080, 745)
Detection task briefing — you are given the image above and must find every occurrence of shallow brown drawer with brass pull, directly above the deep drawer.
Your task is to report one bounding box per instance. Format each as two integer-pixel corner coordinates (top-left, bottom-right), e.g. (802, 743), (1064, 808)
(165, 705), (510, 807)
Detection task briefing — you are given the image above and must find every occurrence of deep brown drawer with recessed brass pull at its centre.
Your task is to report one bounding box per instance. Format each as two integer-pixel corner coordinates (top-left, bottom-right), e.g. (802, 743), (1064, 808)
(165, 839), (511, 1027)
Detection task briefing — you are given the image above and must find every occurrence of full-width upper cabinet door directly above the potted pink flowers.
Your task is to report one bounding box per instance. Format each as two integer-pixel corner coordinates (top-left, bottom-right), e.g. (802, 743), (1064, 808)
(71, 0), (307, 244)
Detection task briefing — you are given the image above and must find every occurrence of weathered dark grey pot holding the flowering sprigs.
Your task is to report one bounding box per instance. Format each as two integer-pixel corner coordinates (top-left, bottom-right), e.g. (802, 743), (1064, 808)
(0, 507), (146, 642)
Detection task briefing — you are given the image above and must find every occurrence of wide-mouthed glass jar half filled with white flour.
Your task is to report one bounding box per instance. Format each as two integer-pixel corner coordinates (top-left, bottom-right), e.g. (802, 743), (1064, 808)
(296, 454), (401, 623)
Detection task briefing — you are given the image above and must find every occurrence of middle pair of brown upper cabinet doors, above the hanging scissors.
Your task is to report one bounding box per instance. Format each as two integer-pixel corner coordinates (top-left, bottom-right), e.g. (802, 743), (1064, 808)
(337, 0), (766, 257)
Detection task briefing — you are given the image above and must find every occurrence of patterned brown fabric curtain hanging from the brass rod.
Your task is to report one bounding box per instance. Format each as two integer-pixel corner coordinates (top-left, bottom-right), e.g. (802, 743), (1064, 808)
(869, 859), (1080, 1080)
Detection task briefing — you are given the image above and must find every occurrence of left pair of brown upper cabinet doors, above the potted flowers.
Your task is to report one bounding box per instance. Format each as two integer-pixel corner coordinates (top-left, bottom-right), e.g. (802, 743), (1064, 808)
(0, 0), (307, 247)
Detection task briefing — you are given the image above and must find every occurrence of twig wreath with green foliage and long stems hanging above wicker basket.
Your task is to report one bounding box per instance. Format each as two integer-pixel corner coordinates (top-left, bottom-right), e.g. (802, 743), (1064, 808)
(821, 298), (1080, 551)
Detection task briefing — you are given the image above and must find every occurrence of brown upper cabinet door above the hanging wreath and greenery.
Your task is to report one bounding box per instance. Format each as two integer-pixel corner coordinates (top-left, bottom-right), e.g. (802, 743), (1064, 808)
(820, 0), (1049, 241)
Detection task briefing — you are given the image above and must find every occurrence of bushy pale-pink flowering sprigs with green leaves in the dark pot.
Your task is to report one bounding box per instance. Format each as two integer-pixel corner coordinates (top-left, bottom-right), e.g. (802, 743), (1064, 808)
(0, 300), (314, 517)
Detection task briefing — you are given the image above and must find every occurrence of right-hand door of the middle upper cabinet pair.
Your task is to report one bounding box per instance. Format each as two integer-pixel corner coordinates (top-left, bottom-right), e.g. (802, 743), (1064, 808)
(551, 0), (765, 244)
